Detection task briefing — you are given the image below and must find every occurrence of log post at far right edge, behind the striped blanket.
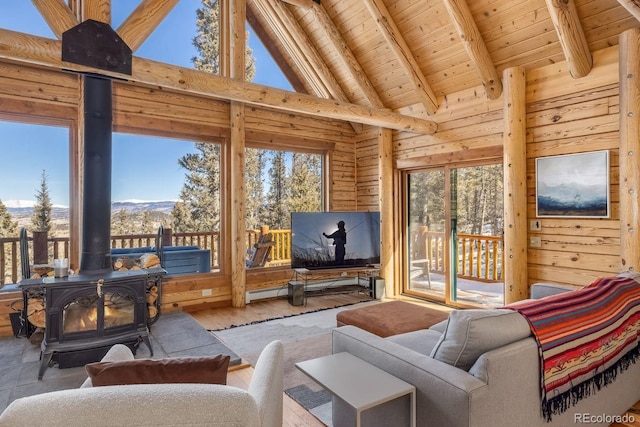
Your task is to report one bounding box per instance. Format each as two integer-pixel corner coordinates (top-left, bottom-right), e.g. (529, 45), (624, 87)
(619, 28), (640, 272)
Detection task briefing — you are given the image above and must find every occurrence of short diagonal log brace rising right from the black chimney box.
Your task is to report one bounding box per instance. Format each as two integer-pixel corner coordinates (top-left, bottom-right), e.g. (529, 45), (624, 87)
(116, 0), (178, 52)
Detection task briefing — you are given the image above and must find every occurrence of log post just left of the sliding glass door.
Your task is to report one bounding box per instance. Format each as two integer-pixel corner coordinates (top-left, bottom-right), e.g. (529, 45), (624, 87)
(378, 128), (398, 296)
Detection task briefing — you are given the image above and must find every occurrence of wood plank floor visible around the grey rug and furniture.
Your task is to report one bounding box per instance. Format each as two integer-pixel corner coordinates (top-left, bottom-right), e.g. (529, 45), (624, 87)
(190, 293), (640, 427)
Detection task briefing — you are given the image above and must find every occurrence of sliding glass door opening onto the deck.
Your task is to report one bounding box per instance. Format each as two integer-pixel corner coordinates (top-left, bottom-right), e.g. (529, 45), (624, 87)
(404, 164), (504, 306)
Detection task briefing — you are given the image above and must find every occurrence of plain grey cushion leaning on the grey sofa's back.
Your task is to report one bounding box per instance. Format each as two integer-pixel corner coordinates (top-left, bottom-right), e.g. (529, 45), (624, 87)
(431, 309), (531, 371)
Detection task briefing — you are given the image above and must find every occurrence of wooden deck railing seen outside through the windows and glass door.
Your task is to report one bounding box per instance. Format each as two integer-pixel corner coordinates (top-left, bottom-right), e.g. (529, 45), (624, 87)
(0, 227), (503, 285)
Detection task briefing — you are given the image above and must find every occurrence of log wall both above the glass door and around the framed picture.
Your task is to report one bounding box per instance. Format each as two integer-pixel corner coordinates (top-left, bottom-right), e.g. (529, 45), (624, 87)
(388, 46), (623, 298)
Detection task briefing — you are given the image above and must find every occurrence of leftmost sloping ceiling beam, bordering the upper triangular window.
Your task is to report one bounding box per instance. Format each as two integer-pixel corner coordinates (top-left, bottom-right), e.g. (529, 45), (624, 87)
(254, 0), (362, 133)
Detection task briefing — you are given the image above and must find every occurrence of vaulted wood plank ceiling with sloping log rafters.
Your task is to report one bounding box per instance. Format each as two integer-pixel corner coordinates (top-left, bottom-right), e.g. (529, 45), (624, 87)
(247, 0), (640, 118)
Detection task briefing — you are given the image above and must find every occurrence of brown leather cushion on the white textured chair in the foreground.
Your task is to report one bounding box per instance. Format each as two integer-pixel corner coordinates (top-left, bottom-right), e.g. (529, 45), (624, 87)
(85, 355), (230, 387)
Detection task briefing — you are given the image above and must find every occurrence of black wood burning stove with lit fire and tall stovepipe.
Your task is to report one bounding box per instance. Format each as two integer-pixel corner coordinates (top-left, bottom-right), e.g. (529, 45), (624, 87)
(20, 66), (164, 379)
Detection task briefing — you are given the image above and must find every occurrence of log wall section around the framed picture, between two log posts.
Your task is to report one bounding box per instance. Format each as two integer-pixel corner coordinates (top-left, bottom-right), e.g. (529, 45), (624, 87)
(527, 46), (622, 285)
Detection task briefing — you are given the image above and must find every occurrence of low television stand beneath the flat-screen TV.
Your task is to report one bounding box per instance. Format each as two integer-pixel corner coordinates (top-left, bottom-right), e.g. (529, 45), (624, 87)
(293, 266), (380, 306)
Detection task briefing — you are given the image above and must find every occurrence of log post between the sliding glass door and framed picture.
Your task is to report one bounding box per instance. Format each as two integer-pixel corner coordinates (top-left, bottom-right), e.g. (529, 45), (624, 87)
(503, 67), (529, 304)
